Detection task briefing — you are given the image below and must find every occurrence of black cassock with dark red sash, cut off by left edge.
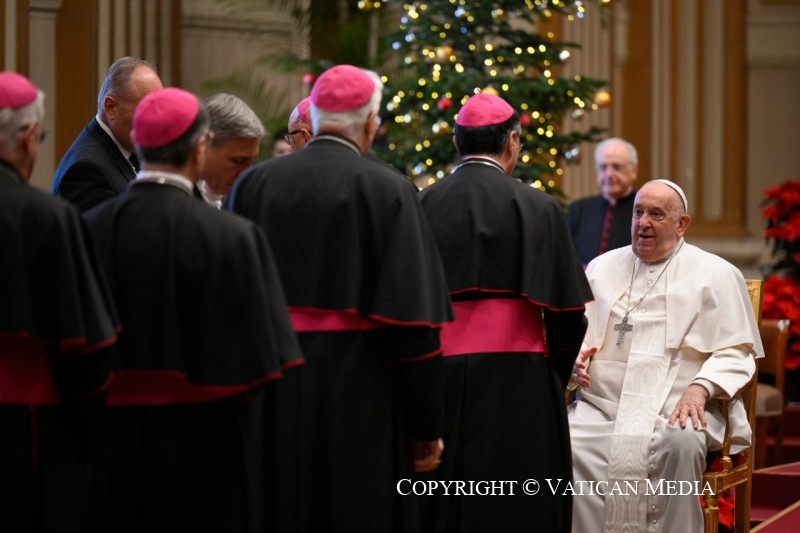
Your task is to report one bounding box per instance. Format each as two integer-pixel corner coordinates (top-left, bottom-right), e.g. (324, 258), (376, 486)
(0, 162), (119, 532)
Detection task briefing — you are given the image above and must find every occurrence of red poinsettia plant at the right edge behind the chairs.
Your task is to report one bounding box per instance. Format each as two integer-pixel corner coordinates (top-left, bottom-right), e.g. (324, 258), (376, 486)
(762, 180), (800, 370)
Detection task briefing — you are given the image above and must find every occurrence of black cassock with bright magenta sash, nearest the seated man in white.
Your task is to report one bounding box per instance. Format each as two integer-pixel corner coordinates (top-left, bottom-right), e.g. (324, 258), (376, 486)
(420, 158), (591, 532)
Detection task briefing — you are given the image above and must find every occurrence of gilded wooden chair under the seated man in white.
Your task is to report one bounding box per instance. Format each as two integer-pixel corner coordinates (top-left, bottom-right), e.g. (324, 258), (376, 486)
(702, 279), (763, 533)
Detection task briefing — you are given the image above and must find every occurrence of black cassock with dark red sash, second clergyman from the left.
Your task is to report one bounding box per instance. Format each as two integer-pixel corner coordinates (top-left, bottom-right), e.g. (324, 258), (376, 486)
(84, 181), (302, 532)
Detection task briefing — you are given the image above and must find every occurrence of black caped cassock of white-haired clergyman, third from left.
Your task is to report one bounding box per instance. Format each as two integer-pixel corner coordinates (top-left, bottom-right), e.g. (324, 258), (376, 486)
(230, 135), (451, 532)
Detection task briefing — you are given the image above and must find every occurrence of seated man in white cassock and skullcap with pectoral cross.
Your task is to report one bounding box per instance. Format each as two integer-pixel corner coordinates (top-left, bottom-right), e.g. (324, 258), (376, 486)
(568, 180), (763, 533)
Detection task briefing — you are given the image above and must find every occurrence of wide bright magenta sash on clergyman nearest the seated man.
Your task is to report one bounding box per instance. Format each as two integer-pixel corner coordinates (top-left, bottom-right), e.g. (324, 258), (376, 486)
(440, 298), (545, 357)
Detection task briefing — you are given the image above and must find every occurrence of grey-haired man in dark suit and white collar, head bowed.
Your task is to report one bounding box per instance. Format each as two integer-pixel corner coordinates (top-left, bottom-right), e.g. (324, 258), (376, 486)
(52, 57), (162, 211)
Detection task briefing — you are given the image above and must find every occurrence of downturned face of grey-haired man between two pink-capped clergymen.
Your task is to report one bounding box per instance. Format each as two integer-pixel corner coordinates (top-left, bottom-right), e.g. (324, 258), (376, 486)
(202, 137), (259, 195)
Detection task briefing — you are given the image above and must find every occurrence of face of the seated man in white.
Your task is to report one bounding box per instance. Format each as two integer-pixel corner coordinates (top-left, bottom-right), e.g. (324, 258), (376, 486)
(631, 183), (691, 263)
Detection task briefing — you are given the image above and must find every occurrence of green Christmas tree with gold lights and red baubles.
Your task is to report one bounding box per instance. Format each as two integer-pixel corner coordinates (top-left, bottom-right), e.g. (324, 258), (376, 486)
(374, 0), (606, 197)
